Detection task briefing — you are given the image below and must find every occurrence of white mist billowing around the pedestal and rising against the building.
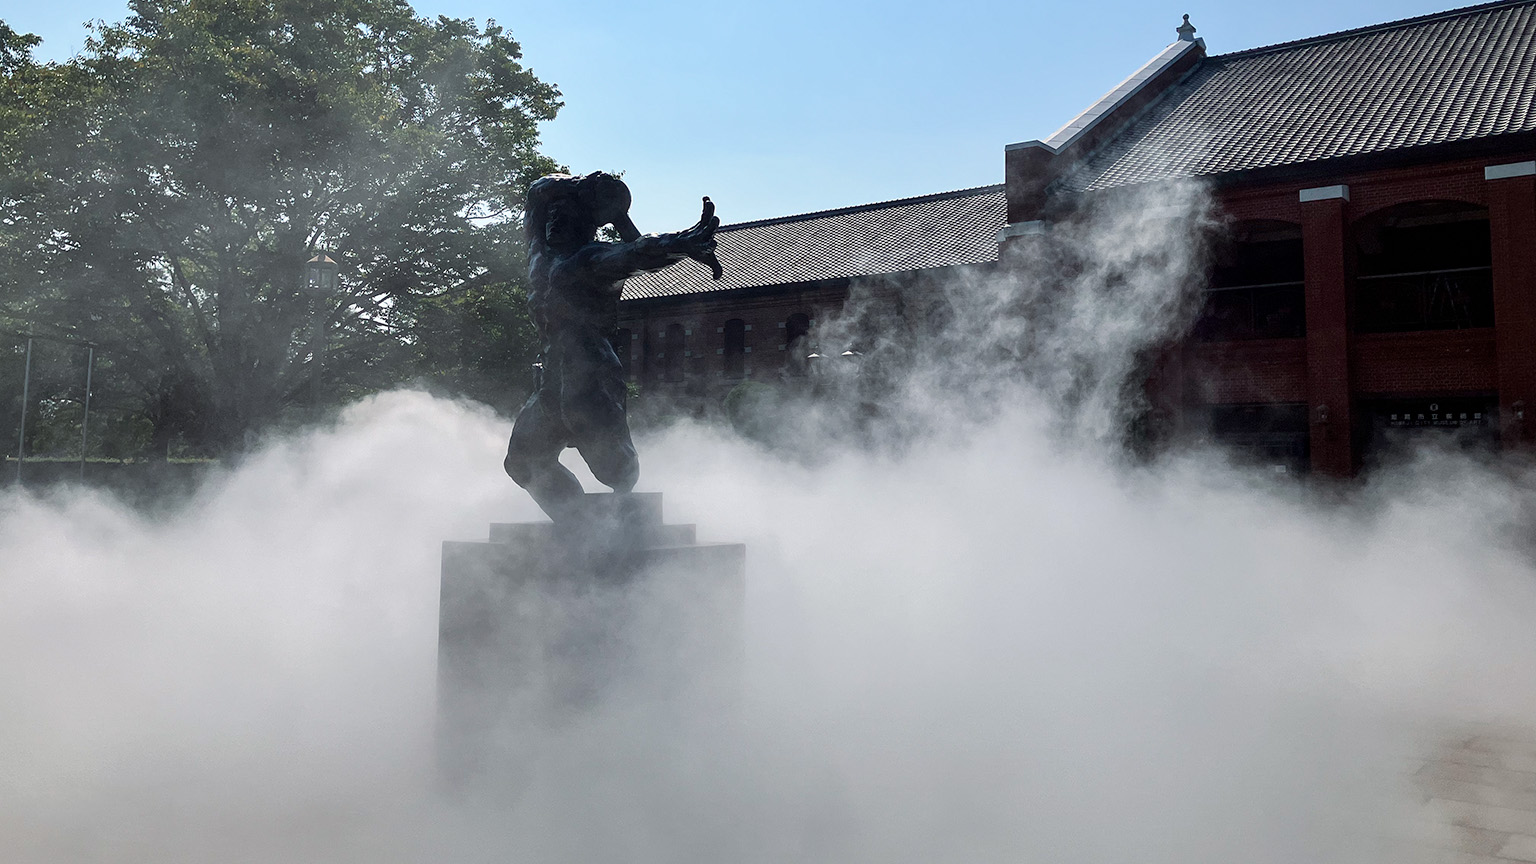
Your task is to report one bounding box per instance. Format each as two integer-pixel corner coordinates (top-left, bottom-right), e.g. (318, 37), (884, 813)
(0, 178), (1536, 864)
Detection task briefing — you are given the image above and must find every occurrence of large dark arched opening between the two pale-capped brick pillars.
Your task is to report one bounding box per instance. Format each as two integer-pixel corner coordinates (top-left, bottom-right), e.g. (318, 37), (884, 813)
(1355, 201), (1493, 334)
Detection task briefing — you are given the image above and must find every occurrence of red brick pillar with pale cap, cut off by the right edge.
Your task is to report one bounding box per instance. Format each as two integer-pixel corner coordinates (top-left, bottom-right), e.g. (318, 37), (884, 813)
(1484, 161), (1536, 447)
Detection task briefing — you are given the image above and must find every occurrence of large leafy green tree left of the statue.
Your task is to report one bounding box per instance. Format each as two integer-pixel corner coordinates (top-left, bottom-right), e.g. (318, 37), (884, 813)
(0, 0), (561, 452)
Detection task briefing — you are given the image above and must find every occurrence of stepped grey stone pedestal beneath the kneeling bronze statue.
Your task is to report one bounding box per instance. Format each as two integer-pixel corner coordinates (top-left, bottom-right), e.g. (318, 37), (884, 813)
(438, 493), (746, 784)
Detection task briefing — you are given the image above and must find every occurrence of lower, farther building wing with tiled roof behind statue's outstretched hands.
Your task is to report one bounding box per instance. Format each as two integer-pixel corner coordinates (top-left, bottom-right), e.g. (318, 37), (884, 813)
(616, 186), (1005, 400)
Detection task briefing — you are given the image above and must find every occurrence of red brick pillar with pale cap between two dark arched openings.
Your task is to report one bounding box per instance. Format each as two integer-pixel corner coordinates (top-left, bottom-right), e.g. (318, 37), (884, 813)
(1301, 186), (1355, 477)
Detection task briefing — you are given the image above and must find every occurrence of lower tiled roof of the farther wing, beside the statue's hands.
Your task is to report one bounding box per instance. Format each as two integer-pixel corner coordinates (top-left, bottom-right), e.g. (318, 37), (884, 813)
(622, 186), (1006, 300)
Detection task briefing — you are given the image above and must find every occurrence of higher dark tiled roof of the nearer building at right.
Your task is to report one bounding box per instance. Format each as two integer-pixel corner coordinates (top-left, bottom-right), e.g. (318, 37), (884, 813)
(1061, 0), (1536, 191)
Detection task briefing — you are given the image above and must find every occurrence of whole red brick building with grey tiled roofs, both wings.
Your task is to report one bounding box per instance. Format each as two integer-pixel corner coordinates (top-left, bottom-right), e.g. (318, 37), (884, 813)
(621, 0), (1536, 475)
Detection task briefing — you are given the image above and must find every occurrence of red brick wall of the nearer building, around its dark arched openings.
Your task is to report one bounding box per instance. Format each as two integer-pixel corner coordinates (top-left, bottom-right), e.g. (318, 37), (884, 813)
(1181, 151), (1536, 474)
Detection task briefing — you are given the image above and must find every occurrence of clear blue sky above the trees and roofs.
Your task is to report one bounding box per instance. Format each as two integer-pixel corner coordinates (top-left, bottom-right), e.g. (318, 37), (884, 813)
(9, 0), (1465, 231)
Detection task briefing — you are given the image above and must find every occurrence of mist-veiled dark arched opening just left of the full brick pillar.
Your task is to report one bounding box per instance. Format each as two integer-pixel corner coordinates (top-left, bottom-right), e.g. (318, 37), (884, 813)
(1195, 220), (1307, 341)
